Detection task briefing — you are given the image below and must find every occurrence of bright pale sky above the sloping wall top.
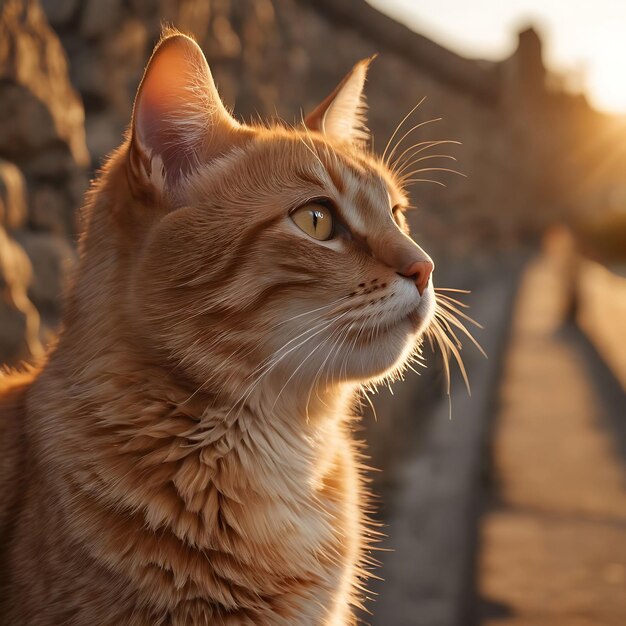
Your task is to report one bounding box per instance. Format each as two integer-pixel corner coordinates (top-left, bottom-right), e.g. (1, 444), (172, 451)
(368, 0), (626, 114)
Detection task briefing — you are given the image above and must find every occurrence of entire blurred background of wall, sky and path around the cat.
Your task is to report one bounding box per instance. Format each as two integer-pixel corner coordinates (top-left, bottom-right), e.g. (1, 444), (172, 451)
(0, 0), (626, 626)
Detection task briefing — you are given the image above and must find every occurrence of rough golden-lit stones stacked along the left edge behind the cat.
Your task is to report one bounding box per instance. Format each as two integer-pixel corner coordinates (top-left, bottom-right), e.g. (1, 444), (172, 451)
(0, 0), (89, 362)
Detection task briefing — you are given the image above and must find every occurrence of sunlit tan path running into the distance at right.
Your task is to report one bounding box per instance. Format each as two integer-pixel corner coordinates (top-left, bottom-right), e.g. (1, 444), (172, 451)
(479, 246), (626, 626)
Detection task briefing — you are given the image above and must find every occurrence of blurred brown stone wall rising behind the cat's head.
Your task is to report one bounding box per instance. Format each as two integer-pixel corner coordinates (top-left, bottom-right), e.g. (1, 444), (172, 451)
(0, 0), (608, 360)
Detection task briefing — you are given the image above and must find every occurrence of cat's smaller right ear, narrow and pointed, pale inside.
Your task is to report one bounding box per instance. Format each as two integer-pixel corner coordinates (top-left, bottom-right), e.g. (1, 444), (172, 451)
(304, 57), (375, 145)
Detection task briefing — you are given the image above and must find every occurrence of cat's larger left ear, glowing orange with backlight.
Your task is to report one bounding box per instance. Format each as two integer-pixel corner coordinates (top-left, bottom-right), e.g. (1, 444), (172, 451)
(130, 32), (239, 196)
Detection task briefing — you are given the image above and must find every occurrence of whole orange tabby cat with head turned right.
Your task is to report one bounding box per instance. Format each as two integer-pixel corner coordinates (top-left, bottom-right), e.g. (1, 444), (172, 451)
(0, 31), (435, 626)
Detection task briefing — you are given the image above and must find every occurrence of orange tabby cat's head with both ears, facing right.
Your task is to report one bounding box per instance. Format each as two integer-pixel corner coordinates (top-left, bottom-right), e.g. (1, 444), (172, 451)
(120, 32), (435, 408)
